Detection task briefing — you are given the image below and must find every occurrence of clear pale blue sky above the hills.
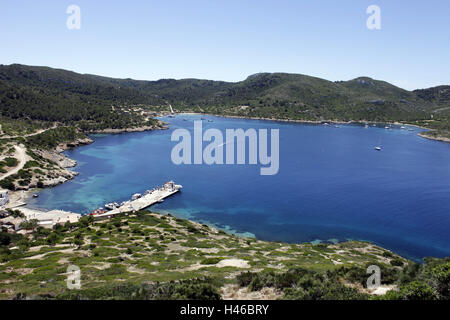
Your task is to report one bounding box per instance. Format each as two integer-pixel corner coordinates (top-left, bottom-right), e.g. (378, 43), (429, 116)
(0, 0), (450, 89)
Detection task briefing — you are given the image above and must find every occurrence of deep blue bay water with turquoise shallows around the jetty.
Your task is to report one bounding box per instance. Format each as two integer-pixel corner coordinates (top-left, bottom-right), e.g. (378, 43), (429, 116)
(30, 115), (450, 260)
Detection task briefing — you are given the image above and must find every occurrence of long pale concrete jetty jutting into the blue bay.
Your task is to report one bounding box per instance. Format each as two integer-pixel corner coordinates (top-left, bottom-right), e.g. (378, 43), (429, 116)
(92, 181), (183, 219)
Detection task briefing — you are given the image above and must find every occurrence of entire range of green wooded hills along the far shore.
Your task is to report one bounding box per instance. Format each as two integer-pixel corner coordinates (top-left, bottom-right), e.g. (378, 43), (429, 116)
(0, 65), (450, 128)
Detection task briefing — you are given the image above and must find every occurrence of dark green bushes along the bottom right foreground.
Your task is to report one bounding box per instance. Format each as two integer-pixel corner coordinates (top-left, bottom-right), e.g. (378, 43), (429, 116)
(237, 258), (450, 300)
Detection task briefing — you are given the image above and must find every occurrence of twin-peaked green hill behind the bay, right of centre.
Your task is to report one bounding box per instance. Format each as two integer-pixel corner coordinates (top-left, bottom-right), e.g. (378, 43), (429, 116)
(211, 73), (431, 121)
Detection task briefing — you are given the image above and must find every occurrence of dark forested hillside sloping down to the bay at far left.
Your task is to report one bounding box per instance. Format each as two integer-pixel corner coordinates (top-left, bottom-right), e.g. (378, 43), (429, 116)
(0, 65), (160, 130)
